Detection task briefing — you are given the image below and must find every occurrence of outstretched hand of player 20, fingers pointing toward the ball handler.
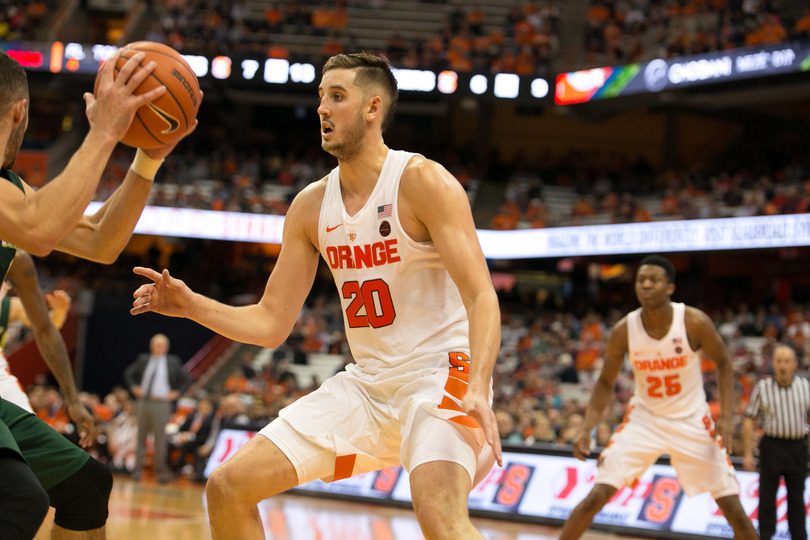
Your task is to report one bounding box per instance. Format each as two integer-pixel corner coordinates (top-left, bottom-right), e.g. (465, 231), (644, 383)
(129, 266), (194, 317)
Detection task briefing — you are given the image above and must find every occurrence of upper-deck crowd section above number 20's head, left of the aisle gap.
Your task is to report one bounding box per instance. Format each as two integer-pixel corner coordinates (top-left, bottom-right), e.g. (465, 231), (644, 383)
(146, 0), (559, 75)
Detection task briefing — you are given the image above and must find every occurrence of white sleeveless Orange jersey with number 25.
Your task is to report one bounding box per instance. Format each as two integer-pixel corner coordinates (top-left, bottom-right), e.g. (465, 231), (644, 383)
(627, 302), (706, 418)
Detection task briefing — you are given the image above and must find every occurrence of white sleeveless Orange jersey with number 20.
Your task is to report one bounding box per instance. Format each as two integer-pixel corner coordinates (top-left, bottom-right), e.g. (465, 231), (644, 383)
(318, 150), (470, 376)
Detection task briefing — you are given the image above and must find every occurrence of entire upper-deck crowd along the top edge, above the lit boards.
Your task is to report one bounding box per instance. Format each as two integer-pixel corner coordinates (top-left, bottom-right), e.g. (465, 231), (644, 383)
(0, 0), (810, 79)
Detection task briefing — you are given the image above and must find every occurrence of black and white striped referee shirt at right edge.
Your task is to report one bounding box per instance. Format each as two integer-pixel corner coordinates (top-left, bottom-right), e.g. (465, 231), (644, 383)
(745, 375), (810, 439)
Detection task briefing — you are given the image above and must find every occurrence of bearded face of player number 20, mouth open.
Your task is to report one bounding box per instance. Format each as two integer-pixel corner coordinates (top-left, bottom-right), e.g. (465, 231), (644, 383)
(318, 69), (366, 161)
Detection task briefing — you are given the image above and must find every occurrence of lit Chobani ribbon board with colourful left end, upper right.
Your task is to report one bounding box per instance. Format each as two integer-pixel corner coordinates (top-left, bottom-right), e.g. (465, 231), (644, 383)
(554, 42), (810, 105)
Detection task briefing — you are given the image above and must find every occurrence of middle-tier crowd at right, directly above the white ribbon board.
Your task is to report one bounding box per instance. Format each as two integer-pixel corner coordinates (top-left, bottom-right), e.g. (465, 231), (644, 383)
(489, 151), (810, 230)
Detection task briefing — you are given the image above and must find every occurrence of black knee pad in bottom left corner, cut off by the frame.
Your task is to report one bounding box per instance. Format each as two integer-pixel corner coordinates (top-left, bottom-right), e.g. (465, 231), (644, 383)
(0, 453), (48, 540)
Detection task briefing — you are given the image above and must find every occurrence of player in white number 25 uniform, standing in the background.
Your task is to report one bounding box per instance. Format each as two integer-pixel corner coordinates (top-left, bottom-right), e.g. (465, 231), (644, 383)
(560, 255), (757, 540)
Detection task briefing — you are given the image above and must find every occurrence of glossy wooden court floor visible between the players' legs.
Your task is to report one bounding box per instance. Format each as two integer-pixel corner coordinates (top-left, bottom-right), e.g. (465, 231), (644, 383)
(34, 475), (641, 540)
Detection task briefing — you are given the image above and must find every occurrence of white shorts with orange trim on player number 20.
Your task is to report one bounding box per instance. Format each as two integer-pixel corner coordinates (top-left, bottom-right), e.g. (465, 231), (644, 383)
(259, 364), (495, 486)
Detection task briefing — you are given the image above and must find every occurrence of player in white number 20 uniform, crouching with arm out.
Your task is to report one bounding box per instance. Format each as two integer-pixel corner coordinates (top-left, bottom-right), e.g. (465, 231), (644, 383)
(132, 54), (501, 540)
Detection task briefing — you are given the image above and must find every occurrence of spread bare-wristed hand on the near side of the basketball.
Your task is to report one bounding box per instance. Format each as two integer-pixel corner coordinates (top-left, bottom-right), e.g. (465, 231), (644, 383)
(84, 50), (166, 141)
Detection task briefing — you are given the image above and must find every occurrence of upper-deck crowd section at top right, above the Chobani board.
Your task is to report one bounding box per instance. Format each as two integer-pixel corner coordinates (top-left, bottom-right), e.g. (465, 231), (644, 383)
(584, 0), (810, 66)
